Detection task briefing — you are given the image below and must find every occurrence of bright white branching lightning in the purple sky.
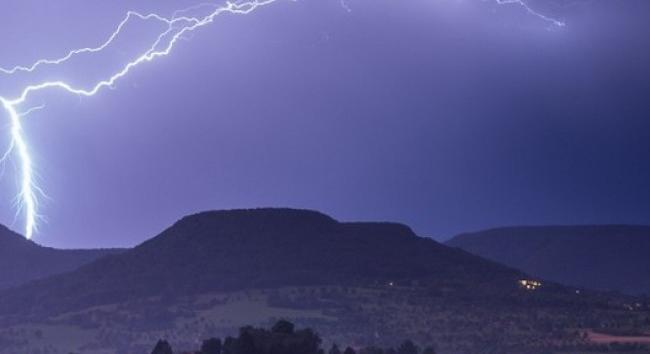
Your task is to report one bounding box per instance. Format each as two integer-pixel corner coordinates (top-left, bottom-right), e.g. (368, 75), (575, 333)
(0, 0), (564, 239)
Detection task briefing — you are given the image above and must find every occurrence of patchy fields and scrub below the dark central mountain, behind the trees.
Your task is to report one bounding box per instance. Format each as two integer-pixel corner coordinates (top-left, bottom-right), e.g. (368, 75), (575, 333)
(0, 286), (648, 354)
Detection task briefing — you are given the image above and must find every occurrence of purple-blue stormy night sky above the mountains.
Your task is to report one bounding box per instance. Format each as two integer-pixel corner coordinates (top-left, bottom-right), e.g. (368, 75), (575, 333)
(0, 0), (650, 248)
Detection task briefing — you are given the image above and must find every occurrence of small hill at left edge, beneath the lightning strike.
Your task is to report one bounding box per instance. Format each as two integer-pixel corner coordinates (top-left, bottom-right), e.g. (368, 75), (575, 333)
(0, 225), (121, 290)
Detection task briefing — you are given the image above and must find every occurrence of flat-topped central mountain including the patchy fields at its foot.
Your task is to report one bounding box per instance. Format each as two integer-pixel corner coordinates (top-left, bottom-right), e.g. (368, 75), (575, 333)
(0, 209), (650, 354)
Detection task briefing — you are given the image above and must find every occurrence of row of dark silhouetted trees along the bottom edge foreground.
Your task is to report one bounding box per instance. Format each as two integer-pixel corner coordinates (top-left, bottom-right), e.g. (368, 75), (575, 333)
(151, 320), (436, 354)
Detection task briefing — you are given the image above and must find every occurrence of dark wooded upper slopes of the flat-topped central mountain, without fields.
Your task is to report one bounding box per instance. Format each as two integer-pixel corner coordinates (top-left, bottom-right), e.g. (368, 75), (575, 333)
(0, 209), (521, 314)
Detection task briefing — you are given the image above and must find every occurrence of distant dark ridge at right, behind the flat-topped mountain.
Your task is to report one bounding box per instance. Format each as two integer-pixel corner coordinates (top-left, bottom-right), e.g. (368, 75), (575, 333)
(447, 225), (650, 294)
